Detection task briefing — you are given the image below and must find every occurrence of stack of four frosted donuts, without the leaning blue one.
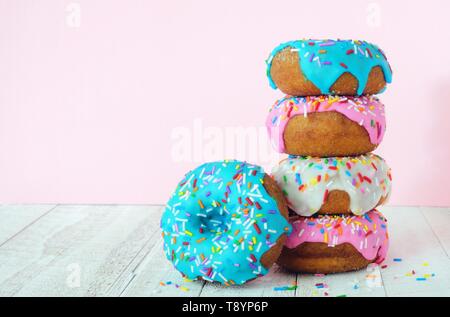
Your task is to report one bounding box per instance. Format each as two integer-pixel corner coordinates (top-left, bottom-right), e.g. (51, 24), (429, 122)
(266, 40), (392, 273)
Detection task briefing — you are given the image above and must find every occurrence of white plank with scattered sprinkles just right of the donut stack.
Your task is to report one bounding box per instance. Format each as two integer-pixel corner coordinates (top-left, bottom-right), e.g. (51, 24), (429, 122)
(381, 207), (450, 296)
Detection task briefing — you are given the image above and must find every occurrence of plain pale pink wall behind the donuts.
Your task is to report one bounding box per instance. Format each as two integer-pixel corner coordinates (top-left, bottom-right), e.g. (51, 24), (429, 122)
(0, 0), (450, 205)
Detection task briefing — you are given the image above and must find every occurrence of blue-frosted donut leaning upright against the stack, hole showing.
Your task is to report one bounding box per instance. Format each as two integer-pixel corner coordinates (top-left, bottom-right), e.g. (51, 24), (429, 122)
(161, 160), (291, 285)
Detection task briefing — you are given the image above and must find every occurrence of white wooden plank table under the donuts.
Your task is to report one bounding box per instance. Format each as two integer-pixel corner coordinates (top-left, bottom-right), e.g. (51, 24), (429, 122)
(0, 205), (450, 297)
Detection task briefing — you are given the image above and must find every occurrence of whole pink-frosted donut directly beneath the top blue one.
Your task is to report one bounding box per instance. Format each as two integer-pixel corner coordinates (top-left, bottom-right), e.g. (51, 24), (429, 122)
(266, 96), (386, 157)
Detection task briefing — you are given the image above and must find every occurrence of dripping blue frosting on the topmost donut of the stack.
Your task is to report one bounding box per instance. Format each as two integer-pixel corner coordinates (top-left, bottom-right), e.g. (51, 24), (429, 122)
(266, 40), (392, 95)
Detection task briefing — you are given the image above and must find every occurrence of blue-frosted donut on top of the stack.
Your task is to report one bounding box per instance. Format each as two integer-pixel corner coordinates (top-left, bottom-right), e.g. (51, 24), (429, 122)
(266, 40), (392, 96)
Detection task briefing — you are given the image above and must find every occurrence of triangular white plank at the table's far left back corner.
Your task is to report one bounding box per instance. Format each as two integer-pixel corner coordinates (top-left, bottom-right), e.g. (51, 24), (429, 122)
(0, 205), (56, 245)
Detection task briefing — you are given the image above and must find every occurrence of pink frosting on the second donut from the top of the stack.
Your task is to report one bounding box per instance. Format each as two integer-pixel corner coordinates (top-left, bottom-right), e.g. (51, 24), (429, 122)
(266, 96), (386, 153)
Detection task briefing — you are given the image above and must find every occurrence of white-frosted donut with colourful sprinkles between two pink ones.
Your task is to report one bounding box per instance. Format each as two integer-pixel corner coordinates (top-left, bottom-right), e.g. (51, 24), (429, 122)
(272, 153), (392, 217)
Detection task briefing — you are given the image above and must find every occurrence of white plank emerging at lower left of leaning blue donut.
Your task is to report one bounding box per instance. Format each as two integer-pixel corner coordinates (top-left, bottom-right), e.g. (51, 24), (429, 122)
(121, 237), (204, 297)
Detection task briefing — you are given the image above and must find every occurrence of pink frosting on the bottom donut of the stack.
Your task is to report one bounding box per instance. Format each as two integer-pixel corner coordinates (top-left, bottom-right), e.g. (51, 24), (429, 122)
(285, 209), (389, 263)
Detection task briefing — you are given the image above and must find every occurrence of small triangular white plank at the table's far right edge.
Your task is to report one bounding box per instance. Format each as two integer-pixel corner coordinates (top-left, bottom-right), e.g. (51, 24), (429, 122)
(420, 207), (450, 257)
